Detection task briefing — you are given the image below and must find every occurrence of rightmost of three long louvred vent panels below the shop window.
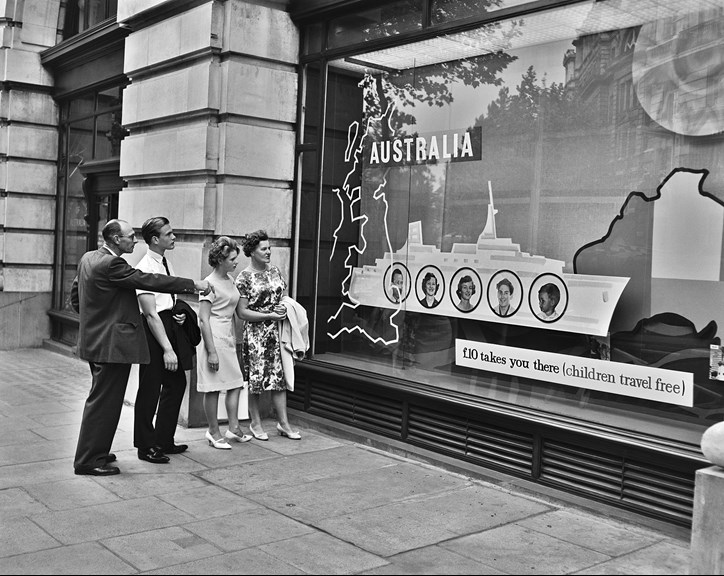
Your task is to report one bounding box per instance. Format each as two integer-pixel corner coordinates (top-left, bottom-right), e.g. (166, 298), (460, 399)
(540, 440), (694, 523)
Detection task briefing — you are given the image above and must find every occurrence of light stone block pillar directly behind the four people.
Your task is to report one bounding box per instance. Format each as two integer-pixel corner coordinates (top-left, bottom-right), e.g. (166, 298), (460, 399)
(117, 0), (299, 426)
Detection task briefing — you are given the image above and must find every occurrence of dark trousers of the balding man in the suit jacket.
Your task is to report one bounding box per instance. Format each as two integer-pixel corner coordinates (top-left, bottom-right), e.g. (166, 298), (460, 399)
(73, 362), (131, 470)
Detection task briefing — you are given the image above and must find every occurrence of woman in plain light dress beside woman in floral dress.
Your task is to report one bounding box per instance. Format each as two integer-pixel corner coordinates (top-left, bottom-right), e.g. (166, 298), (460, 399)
(196, 236), (251, 450)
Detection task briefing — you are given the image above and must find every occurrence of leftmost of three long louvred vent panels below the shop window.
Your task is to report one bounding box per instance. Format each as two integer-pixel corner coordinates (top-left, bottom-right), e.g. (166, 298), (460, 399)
(309, 382), (402, 438)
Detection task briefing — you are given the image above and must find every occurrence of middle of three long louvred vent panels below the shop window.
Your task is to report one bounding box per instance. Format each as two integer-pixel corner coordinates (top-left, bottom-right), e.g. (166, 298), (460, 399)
(407, 405), (533, 477)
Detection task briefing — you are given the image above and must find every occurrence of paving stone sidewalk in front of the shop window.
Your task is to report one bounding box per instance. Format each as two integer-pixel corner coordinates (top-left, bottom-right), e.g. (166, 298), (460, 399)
(0, 349), (689, 574)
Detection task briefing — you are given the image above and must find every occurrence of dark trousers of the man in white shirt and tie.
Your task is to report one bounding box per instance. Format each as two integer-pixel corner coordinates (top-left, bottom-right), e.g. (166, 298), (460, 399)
(133, 319), (186, 450)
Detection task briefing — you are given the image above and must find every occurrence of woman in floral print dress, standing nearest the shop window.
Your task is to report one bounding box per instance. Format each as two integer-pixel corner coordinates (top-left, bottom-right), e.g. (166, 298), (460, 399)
(236, 230), (301, 440)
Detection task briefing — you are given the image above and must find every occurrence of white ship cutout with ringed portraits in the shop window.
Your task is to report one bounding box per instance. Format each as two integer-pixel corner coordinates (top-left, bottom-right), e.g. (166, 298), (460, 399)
(349, 183), (629, 336)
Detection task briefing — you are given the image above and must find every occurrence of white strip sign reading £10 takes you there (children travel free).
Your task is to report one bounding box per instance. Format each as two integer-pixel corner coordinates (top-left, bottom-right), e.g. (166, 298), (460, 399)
(455, 338), (694, 406)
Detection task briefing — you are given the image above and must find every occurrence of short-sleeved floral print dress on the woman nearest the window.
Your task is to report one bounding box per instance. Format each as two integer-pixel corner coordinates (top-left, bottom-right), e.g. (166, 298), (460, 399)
(236, 265), (287, 394)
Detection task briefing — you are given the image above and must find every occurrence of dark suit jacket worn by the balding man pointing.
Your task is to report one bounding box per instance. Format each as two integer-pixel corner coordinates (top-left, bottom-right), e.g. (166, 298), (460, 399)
(71, 248), (195, 364)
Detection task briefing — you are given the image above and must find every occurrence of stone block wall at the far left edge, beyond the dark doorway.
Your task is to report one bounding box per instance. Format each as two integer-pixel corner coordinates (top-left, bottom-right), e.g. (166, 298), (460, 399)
(0, 0), (60, 349)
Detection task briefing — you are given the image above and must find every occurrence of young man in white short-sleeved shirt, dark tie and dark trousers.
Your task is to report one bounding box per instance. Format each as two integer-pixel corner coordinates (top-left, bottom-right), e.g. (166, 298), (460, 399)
(133, 216), (188, 464)
